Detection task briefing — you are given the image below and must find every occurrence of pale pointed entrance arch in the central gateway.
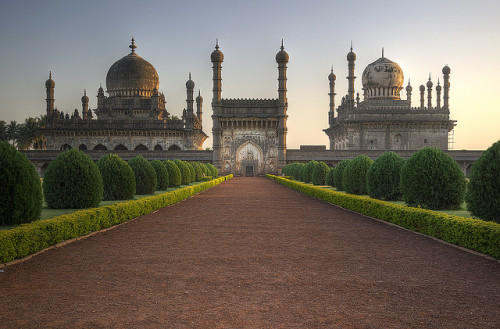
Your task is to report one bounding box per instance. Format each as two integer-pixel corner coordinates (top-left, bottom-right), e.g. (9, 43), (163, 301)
(235, 141), (264, 176)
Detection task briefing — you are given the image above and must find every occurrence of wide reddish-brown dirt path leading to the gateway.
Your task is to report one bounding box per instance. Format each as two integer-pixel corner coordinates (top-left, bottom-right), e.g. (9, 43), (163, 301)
(0, 178), (500, 328)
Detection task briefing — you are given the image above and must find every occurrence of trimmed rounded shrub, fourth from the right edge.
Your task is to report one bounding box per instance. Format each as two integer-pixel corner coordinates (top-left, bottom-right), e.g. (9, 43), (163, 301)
(342, 155), (373, 195)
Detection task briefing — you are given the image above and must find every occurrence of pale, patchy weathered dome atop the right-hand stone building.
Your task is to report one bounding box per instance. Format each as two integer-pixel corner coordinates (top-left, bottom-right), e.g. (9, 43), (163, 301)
(362, 56), (404, 99)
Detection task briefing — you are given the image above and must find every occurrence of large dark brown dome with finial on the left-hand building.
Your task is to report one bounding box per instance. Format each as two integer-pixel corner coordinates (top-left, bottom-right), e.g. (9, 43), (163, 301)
(106, 39), (159, 97)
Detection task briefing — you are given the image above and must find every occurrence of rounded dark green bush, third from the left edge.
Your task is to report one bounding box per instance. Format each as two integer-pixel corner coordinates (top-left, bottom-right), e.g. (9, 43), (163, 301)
(97, 154), (135, 200)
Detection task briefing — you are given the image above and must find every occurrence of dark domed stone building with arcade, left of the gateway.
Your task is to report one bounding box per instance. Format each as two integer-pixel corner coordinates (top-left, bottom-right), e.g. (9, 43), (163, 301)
(44, 38), (207, 151)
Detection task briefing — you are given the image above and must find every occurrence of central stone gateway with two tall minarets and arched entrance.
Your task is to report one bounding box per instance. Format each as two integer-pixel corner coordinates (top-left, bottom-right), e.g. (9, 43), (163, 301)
(211, 42), (289, 176)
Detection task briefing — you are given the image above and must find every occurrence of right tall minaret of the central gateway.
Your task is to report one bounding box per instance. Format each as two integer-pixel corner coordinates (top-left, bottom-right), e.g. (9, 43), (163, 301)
(276, 39), (290, 174)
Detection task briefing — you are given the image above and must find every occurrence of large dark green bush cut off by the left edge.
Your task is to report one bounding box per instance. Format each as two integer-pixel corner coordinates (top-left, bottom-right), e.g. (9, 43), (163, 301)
(0, 142), (43, 225)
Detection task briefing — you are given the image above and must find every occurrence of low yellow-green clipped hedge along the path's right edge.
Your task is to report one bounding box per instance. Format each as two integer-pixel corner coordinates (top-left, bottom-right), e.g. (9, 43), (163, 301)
(267, 175), (500, 259)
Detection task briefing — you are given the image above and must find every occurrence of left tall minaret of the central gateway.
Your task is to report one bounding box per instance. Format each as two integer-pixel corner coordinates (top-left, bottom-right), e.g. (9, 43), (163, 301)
(210, 39), (224, 172)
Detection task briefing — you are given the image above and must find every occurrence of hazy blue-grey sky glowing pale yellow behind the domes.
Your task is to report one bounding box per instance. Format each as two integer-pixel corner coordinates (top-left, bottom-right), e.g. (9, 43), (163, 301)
(0, 0), (500, 150)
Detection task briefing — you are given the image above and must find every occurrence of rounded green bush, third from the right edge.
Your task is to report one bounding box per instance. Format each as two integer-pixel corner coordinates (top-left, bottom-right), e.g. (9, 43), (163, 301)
(366, 152), (405, 200)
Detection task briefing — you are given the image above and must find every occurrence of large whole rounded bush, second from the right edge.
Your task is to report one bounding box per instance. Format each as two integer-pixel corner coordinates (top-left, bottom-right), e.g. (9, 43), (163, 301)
(401, 147), (466, 209)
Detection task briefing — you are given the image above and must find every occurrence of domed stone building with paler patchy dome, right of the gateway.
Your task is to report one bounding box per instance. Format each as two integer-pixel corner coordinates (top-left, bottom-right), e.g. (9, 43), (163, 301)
(324, 47), (456, 150)
